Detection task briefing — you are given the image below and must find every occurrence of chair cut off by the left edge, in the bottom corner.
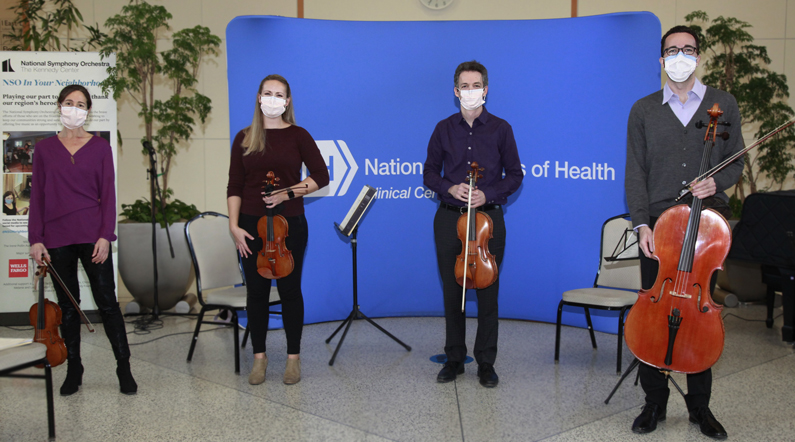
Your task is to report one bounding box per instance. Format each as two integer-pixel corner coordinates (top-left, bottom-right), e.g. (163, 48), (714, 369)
(0, 338), (55, 441)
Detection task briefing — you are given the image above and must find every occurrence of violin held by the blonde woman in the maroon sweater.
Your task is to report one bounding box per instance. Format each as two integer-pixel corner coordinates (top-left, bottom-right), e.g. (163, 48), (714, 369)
(257, 171), (295, 279)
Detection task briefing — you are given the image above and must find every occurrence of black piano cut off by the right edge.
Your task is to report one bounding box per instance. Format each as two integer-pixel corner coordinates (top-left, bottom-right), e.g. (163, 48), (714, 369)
(729, 190), (795, 342)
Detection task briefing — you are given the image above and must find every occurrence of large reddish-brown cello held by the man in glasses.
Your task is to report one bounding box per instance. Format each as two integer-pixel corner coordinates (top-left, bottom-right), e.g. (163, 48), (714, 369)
(624, 103), (731, 373)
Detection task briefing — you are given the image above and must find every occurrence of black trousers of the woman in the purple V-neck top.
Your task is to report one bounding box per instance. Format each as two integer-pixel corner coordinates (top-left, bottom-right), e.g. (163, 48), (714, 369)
(48, 244), (130, 362)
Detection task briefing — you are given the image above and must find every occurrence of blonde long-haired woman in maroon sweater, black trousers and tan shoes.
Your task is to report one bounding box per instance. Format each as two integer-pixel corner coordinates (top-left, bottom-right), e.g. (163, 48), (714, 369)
(226, 75), (329, 385)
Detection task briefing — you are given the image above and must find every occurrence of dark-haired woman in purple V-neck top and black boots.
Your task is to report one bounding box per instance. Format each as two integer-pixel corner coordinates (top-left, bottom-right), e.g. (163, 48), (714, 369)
(28, 85), (138, 396)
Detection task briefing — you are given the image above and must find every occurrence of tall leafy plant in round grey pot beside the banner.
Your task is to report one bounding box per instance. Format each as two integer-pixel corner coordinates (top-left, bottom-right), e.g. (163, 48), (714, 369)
(100, 0), (221, 310)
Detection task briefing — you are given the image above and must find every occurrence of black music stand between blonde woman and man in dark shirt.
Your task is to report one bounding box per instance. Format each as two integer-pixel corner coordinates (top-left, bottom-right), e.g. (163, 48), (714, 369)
(326, 186), (411, 365)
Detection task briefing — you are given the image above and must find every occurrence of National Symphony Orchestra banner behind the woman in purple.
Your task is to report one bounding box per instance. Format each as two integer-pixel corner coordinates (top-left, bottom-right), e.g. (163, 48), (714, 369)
(0, 52), (118, 314)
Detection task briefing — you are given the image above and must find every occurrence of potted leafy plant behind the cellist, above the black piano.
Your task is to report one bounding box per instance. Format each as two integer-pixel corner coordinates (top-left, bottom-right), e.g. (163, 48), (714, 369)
(685, 11), (795, 307)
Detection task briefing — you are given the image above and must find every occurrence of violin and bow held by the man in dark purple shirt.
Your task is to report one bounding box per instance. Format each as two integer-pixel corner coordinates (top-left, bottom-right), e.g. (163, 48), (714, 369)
(455, 161), (497, 312)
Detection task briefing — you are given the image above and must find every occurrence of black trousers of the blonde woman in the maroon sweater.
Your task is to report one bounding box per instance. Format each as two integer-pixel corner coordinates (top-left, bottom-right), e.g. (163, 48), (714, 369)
(238, 213), (309, 355)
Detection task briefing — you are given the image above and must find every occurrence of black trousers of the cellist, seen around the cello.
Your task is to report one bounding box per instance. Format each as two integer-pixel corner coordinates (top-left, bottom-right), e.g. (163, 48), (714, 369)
(638, 217), (717, 410)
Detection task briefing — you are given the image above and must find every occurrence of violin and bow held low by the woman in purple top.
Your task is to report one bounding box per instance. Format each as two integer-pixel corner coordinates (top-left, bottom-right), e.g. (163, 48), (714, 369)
(28, 258), (94, 368)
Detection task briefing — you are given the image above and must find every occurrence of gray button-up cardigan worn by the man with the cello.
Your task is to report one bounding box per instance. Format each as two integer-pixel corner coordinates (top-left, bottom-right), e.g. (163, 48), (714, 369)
(624, 86), (745, 226)
